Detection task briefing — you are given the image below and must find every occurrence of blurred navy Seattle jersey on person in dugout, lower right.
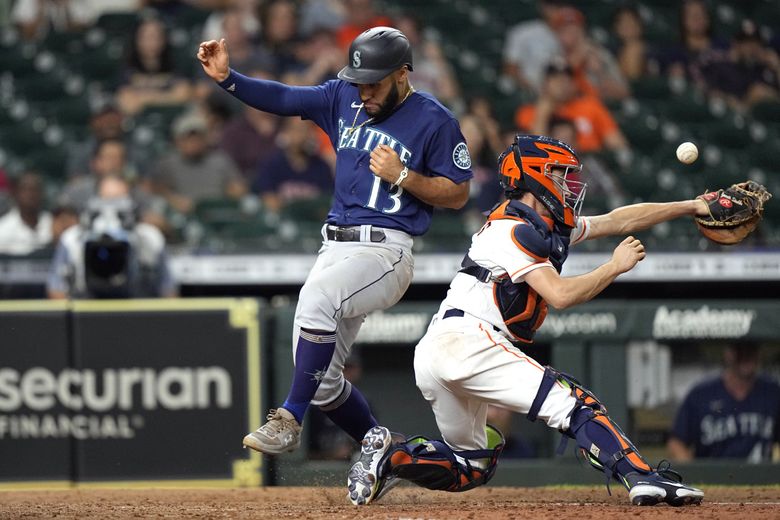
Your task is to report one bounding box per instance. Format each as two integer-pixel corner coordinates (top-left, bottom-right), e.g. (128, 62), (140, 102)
(672, 377), (780, 462)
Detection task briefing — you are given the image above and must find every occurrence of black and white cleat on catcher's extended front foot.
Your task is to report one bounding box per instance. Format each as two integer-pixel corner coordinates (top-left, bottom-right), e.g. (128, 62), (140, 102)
(626, 466), (704, 507)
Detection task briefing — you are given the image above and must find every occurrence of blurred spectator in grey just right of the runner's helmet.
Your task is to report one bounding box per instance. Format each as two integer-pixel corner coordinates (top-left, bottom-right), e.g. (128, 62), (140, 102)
(396, 14), (463, 112)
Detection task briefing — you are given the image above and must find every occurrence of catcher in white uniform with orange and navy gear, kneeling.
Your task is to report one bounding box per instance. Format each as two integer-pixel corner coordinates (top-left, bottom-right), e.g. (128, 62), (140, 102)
(347, 135), (707, 506)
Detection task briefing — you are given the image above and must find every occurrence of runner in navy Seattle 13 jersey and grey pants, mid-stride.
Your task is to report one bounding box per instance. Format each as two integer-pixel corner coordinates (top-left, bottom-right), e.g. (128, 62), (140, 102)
(198, 27), (472, 454)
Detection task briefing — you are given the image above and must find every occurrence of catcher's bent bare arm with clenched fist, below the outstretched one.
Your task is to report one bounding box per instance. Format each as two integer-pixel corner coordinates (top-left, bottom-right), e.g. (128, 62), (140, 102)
(525, 237), (645, 309)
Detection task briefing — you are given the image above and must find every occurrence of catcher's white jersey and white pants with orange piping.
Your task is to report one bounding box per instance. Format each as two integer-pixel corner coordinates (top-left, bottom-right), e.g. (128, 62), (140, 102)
(414, 213), (589, 450)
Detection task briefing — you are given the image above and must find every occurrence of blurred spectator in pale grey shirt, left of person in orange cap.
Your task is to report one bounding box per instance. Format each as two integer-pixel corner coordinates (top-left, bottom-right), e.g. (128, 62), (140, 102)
(503, 0), (561, 92)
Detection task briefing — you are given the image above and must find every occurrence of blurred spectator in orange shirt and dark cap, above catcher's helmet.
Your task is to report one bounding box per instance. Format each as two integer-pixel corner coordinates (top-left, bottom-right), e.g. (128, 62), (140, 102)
(515, 59), (628, 153)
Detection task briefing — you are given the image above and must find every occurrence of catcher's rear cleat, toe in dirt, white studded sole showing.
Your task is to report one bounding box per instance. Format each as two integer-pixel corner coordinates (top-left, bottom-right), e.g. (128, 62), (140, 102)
(347, 426), (396, 506)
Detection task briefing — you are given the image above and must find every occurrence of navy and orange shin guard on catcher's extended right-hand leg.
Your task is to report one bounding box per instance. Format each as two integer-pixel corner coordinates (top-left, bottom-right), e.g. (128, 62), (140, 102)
(528, 367), (653, 487)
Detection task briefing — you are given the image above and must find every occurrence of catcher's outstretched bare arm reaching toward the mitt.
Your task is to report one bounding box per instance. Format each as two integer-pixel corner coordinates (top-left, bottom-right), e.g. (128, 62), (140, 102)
(586, 199), (709, 240)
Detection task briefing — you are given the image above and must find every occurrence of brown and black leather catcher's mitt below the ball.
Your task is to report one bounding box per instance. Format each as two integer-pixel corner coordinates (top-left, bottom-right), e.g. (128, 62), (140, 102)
(695, 181), (772, 245)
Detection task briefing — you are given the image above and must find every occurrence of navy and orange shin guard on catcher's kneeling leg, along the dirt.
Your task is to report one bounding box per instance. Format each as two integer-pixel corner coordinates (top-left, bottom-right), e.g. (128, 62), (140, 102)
(387, 425), (504, 492)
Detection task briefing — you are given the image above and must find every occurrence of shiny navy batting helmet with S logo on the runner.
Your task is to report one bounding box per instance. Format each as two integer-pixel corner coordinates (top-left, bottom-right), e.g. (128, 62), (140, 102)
(338, 27), (412, 84)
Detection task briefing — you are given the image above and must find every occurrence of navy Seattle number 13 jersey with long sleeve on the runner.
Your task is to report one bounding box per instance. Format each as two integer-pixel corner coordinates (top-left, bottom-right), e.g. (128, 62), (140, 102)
(220, 70), (472, 235)
